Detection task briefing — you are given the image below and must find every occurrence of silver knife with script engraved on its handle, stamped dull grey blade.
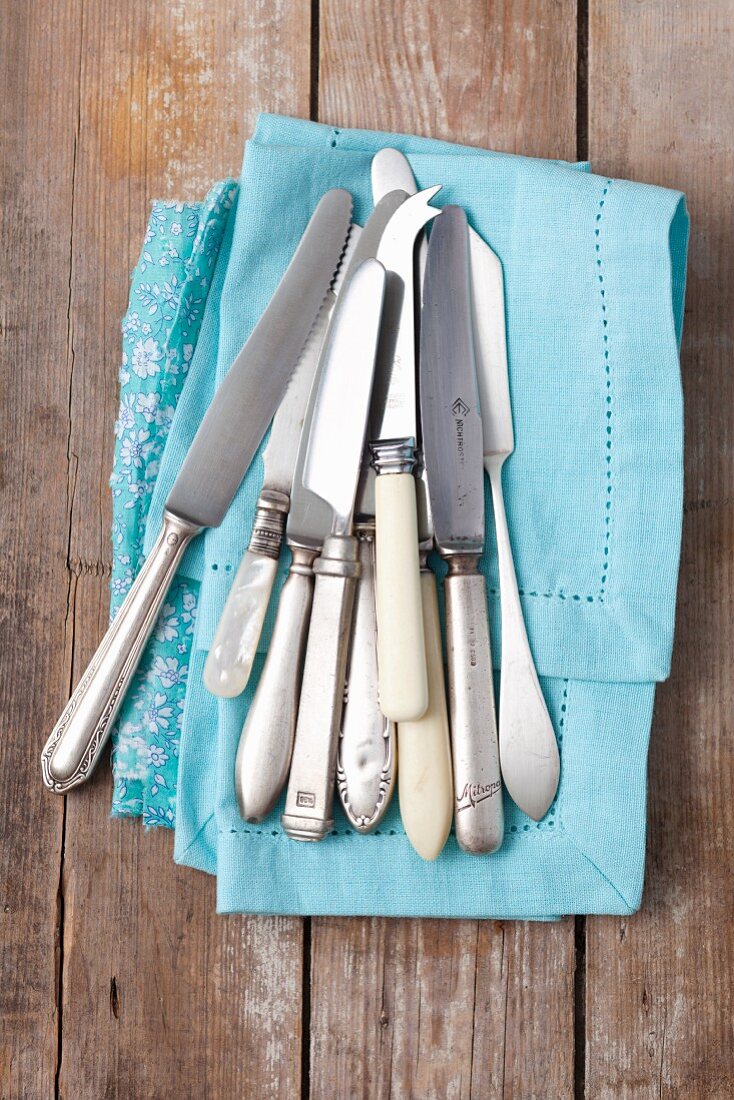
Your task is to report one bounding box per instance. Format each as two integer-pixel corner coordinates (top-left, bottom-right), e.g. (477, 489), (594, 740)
(420, 206), (504, 855)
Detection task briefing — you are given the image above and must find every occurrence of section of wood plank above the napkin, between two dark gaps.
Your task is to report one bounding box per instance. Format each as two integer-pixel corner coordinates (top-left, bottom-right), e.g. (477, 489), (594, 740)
(318, 0), (577, 160)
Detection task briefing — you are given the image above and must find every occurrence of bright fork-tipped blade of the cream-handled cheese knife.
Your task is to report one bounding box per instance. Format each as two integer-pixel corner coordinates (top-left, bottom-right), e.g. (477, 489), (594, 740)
(370, 185), (441, 442)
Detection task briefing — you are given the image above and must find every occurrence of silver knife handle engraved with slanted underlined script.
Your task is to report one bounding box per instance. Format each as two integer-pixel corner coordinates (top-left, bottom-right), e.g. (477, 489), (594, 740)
(445, 554), (504, 855)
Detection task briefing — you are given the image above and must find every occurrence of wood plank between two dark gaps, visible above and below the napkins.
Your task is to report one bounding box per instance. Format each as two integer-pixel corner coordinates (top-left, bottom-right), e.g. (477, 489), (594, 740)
(310, 0), (577, 1100)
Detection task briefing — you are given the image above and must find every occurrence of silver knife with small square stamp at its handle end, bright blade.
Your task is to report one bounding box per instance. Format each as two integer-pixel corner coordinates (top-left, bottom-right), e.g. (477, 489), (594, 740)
(282, 259), (387, 840)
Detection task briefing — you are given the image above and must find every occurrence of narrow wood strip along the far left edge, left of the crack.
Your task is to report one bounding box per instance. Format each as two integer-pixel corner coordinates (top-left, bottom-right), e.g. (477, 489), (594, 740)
(0, 0), (80, 1098)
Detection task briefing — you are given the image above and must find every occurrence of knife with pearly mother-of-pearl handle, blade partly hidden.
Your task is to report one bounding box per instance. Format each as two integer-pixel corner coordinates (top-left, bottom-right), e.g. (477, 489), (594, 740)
(204, 226), (361, 699)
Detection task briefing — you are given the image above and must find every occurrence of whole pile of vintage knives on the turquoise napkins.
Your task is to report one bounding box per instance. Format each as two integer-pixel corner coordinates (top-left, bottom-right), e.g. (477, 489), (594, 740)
(42, 149), (559, 859)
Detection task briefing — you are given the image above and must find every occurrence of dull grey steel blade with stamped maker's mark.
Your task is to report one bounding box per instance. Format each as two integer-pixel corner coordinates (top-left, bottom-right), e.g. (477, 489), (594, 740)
(420, 207), (484, 553)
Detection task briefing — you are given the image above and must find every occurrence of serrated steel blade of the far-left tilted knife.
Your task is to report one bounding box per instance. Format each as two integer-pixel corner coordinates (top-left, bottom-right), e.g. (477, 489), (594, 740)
(166, 190), (352, 527)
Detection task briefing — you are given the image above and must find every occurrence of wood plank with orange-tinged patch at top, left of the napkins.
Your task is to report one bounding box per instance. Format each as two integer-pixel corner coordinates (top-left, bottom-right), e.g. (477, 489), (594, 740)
(53, 0), (310, 1100)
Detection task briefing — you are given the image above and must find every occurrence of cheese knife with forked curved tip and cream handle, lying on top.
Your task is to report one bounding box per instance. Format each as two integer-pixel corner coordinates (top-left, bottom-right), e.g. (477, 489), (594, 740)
(370, 187), (440, 722)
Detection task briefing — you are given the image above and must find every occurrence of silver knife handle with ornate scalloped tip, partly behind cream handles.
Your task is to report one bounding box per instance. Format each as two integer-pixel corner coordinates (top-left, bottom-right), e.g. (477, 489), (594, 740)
(337, 524), (397, 833)
